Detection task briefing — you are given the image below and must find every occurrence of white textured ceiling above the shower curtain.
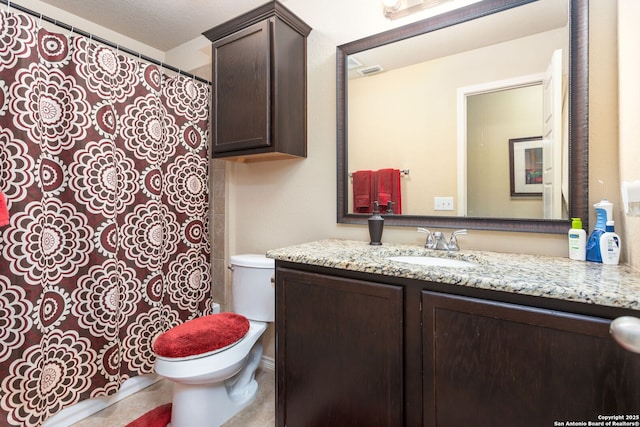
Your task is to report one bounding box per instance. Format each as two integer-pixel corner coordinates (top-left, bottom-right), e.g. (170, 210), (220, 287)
(33, 0), (276, 52)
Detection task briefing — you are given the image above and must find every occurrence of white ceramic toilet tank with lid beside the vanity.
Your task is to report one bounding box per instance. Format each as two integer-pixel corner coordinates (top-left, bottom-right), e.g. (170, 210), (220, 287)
(230, 254), (276, 322)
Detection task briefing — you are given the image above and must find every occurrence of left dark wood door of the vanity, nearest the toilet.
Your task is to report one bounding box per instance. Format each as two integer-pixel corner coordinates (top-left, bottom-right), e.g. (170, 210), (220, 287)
(276, 269), (403, 427)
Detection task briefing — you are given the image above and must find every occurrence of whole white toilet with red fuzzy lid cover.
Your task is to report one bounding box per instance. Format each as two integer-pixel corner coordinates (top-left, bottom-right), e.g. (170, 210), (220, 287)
(153, 254), (275, 427)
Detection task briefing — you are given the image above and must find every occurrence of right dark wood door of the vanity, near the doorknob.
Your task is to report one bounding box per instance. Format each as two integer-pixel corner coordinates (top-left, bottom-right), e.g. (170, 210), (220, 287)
(422, 292), (640, 427)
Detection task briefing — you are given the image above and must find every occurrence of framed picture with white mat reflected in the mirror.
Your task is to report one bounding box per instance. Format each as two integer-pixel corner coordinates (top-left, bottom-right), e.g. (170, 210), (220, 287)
(509, 136), (543, 197)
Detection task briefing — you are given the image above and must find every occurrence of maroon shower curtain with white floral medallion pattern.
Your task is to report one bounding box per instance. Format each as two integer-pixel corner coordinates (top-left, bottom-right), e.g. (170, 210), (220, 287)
(0, 10), (212, 426)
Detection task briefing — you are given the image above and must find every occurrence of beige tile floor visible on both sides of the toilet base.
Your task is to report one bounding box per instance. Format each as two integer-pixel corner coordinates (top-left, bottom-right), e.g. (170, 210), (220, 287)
(71, 368), (275, 427)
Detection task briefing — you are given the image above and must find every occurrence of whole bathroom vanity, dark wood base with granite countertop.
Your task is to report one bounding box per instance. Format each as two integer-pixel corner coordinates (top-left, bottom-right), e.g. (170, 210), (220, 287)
(267, 239), (640, 427)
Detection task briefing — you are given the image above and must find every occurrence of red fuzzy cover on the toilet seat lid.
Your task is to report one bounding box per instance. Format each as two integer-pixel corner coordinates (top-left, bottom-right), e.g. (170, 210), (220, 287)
(153, 313), (249, 358)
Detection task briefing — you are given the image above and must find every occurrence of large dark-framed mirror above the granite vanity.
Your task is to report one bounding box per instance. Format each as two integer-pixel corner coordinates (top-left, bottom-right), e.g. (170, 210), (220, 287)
(336, 0), (589, 233)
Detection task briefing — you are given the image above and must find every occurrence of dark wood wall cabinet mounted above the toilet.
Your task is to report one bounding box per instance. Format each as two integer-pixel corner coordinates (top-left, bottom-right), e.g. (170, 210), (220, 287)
(204, 1), (311, 162)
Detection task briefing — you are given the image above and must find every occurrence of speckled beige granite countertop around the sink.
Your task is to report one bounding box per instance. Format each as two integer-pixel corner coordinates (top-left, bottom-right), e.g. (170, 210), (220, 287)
(267, 239), (640, 310)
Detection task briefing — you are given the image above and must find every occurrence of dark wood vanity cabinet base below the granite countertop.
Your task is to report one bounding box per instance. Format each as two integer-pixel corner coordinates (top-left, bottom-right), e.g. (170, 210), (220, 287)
(275, 261), (640, 427)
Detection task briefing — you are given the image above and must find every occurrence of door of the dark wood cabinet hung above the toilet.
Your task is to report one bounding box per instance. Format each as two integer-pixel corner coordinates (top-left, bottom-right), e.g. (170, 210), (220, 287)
(212, 20), (272, 153)
